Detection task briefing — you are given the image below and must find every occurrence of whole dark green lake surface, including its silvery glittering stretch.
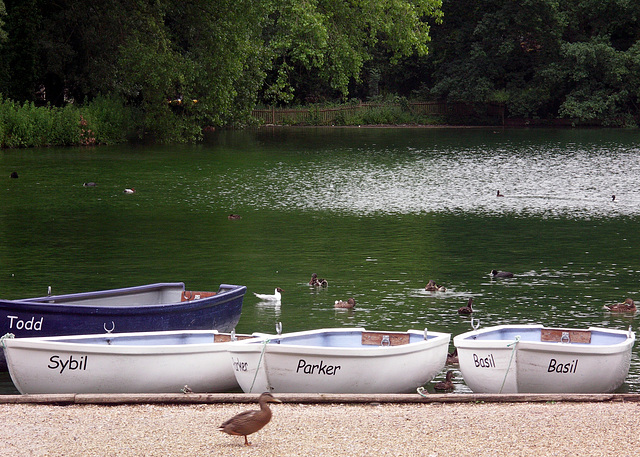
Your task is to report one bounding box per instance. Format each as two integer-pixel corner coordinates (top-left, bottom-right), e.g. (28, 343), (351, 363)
(0, 128), (640, 393)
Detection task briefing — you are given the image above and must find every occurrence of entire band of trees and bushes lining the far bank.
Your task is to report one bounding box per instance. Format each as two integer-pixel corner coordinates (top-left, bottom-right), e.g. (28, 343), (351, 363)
(0, 0), (640, 146)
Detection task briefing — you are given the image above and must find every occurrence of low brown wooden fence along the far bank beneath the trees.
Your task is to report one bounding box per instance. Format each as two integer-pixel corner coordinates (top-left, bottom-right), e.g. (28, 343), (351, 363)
(252, 102), (504, 125)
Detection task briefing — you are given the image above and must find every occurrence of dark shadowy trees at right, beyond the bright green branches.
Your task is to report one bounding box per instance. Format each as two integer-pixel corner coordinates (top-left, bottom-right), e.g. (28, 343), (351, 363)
(423, 0), (640, 125)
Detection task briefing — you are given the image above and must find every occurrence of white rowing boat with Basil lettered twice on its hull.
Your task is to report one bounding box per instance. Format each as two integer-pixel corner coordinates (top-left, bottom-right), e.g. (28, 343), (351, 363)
(453, 325), (635, 393)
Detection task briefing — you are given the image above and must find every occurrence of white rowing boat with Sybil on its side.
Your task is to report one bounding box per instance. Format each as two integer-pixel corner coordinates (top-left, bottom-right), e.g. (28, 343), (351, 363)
(2, 330), (252, 394)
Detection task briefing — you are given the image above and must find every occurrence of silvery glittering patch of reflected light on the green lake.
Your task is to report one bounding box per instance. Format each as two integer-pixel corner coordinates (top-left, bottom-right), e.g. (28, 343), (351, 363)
(193, 129), (640, 219)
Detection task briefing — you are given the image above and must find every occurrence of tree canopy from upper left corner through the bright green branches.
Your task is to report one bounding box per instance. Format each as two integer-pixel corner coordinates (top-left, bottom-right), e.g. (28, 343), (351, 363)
(0, 0), (441, 139)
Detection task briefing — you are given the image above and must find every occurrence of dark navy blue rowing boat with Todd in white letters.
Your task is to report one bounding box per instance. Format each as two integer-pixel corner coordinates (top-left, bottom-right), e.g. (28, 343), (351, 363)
(0, 282), (247, 371)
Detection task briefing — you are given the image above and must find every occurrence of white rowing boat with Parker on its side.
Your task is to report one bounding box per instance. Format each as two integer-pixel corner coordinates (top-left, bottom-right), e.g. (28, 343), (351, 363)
(229, 328), (451, 393)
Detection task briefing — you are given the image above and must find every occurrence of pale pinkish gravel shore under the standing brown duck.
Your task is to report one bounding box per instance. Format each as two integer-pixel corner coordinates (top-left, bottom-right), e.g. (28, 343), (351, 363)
(0, 395), (640, 457)
